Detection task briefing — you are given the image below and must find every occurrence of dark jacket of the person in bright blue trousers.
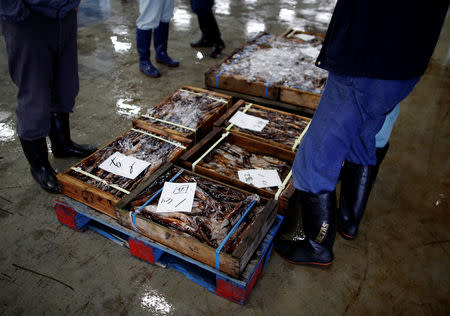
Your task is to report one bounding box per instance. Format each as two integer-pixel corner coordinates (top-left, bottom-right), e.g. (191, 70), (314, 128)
(316, 0), (449, 80)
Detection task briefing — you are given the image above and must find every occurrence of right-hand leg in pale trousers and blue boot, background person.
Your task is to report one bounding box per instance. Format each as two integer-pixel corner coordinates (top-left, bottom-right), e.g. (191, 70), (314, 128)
(153, 0), (180, 67)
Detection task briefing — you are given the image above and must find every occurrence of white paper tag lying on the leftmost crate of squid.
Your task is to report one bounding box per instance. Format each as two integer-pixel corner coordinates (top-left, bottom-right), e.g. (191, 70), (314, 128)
(99, 151), (150, 179)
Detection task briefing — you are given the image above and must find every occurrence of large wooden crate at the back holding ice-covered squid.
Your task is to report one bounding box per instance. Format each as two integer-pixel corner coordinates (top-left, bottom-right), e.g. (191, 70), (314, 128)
(205, 29), (324, 112)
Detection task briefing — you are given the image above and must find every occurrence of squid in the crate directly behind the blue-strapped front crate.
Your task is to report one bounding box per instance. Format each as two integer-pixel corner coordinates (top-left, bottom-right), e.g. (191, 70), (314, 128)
(197, 141), (292, 192)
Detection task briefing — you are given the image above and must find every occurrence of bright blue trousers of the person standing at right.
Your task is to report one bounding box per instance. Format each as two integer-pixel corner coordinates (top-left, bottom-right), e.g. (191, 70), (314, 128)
(293, 73), (419, 194)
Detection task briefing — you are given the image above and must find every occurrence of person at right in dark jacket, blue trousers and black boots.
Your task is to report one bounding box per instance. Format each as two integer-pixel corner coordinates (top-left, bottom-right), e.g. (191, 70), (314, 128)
(275, 0), (449, 267)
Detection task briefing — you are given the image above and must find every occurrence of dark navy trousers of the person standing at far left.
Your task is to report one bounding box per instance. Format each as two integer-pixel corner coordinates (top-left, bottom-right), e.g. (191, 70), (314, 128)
(2, 11), (79, 140)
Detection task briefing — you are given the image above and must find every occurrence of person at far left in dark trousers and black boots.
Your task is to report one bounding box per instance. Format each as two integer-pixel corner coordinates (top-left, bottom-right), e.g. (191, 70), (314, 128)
(0, 0), (97, 193)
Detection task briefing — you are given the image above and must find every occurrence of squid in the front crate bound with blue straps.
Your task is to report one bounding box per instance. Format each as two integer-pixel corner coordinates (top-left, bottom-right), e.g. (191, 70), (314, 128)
(129, 168), (263, 253)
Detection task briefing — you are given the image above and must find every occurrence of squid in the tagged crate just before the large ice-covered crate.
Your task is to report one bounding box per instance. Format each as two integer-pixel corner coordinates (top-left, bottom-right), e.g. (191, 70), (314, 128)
(214, 100), (311, 152)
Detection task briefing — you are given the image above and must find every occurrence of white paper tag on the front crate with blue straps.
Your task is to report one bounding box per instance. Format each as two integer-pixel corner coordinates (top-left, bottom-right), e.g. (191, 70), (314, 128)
(156, 182), (197, 213)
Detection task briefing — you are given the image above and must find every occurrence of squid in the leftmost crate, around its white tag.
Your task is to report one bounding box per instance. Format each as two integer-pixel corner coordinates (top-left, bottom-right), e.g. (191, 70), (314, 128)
(68, 131), (182, 198)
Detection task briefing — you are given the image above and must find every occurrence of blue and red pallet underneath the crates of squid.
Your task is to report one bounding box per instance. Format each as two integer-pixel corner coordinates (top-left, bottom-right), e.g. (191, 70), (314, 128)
(54, 197), (283, 304)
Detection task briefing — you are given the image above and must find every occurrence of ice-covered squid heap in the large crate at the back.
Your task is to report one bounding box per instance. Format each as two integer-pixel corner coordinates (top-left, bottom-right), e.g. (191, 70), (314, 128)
(215, 35), (328, 93)
